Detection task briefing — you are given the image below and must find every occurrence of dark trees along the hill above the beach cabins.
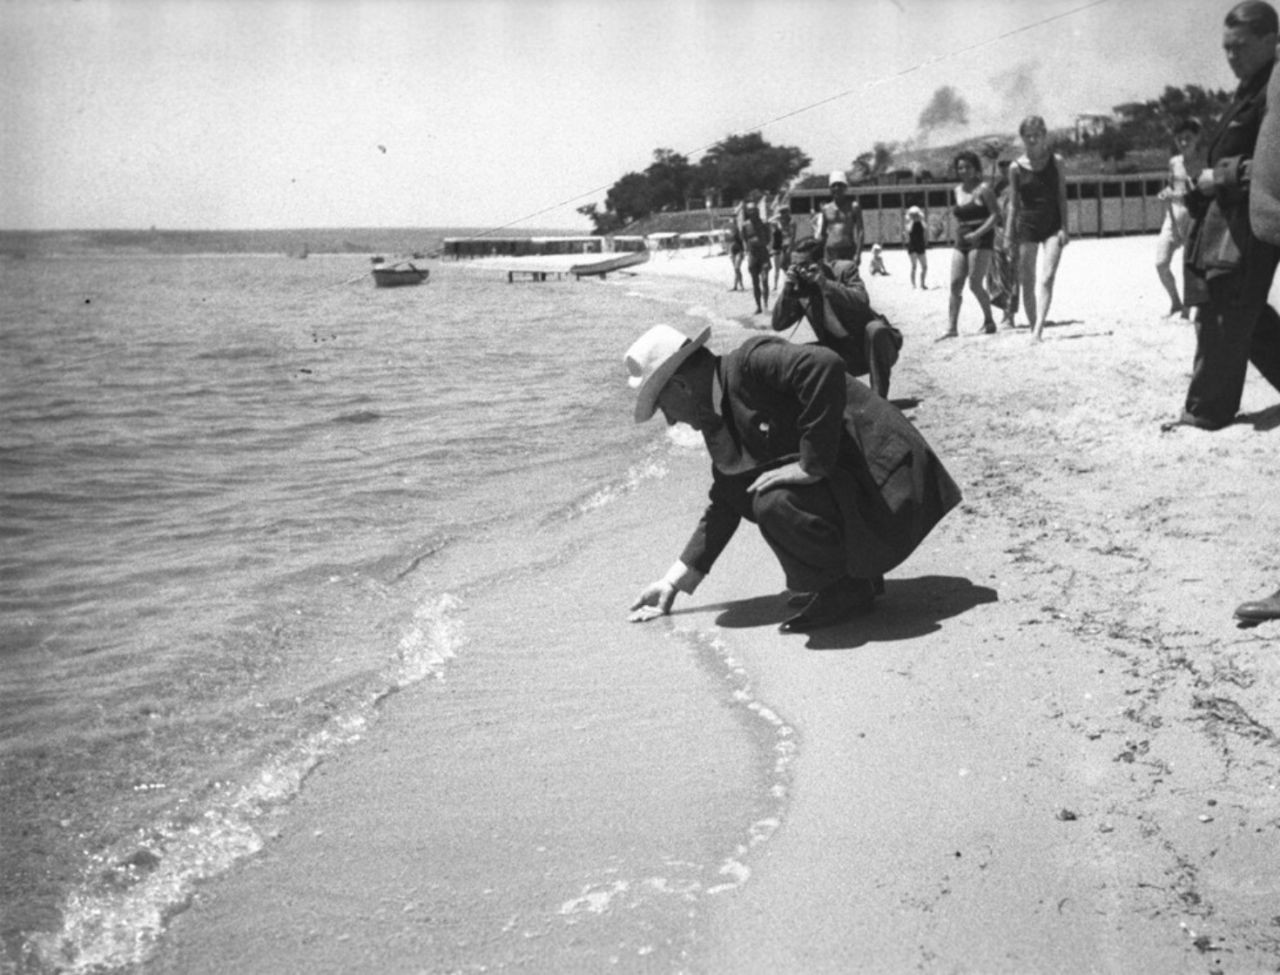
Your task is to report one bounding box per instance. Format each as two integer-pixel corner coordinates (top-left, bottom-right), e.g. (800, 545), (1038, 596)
(577, 84), (1231, 234)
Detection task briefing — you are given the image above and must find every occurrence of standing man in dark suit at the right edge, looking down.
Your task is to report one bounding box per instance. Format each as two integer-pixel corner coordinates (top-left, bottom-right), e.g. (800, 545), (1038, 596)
(1166, 0), (1280, 430)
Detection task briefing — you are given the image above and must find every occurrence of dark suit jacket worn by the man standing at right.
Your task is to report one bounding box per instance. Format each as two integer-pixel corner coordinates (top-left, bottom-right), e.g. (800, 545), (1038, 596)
(1185, 58), (1275, 305)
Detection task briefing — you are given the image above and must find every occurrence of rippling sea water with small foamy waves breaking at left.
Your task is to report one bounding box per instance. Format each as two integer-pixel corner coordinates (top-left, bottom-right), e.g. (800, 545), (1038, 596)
(0, 241), (777, 971)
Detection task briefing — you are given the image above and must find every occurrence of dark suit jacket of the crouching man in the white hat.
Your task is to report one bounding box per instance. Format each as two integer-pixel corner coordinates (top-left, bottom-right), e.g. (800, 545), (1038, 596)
(681, 335), (960, 578)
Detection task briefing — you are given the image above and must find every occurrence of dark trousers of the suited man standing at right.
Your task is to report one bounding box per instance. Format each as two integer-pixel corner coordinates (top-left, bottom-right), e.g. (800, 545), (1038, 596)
(1183, 262), (1280, 430)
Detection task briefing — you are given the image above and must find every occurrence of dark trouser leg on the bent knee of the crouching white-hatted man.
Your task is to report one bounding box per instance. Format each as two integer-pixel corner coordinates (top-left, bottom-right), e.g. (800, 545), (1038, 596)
(751, 480), (847, 592)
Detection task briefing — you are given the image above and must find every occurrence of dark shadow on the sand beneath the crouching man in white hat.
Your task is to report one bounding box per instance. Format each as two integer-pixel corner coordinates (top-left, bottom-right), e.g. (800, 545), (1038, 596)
(708, 576), (1000, 650)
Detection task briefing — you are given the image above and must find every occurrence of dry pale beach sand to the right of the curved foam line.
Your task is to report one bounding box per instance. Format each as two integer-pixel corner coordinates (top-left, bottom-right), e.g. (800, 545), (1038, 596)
(634, 238), (1280, 972)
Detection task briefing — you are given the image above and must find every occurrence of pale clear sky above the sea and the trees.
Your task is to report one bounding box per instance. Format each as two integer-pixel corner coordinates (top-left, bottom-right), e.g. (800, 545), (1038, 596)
(0, 0), (1235, 229)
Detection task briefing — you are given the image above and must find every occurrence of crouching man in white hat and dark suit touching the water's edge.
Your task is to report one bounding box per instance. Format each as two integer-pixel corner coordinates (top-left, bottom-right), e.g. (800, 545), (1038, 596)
(626, 325), (960, 633)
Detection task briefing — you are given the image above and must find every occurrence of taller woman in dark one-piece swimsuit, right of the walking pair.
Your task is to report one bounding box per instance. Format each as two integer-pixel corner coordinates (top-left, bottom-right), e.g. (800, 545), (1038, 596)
(1005, 115), (1069, 342)
